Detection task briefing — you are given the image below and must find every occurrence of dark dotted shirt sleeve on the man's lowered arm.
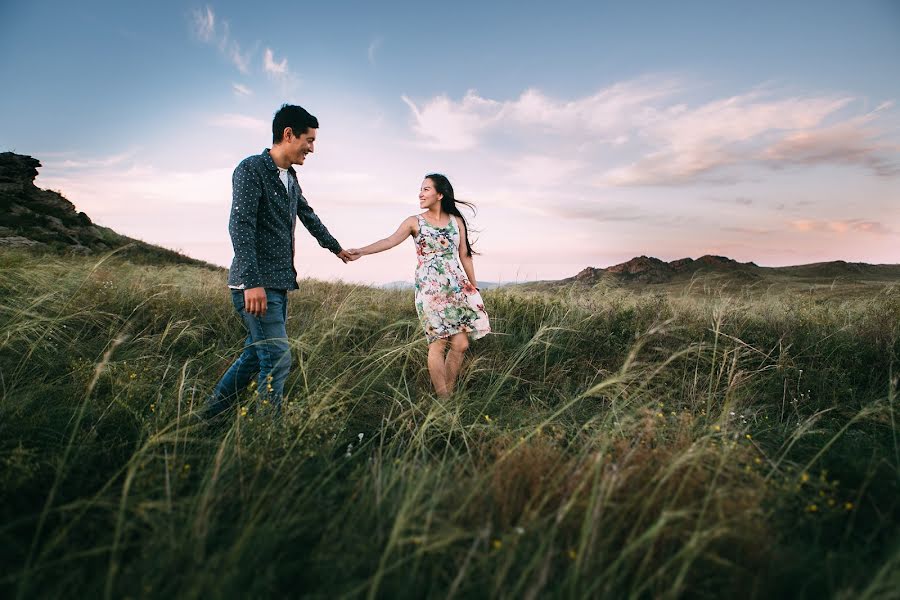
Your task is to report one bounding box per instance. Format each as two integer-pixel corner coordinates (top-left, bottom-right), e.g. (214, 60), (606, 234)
(228, 161), (263, 288)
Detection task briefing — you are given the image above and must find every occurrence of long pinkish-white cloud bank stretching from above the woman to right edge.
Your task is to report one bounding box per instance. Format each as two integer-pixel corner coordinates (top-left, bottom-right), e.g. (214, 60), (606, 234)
(402, 77), (900, 187)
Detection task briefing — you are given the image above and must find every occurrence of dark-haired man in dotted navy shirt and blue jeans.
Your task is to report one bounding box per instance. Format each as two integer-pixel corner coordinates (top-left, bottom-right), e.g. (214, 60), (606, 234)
(206, 104), (356, 417)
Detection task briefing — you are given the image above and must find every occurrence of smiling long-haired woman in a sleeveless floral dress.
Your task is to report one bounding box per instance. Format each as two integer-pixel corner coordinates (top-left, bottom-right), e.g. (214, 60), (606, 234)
(348, 173), (491, 397)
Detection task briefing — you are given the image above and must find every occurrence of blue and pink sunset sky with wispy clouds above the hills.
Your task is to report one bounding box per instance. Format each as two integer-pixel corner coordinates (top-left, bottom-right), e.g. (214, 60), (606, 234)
(0, 0), (900, 284)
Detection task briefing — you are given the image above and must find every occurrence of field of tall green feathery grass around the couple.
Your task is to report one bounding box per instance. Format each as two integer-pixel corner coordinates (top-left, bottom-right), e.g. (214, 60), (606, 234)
(0, 247), (900, 599)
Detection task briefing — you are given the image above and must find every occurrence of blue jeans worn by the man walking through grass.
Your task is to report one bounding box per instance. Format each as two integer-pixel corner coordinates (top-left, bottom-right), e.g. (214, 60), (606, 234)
(206, 288), (291, 417)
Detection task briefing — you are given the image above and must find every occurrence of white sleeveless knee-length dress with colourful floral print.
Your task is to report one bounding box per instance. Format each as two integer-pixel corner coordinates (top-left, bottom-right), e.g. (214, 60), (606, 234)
(415, 215), (491, 344)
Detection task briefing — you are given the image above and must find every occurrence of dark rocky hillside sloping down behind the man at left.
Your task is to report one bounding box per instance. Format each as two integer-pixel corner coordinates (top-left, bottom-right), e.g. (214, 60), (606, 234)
(0, 152), (220, 270)
